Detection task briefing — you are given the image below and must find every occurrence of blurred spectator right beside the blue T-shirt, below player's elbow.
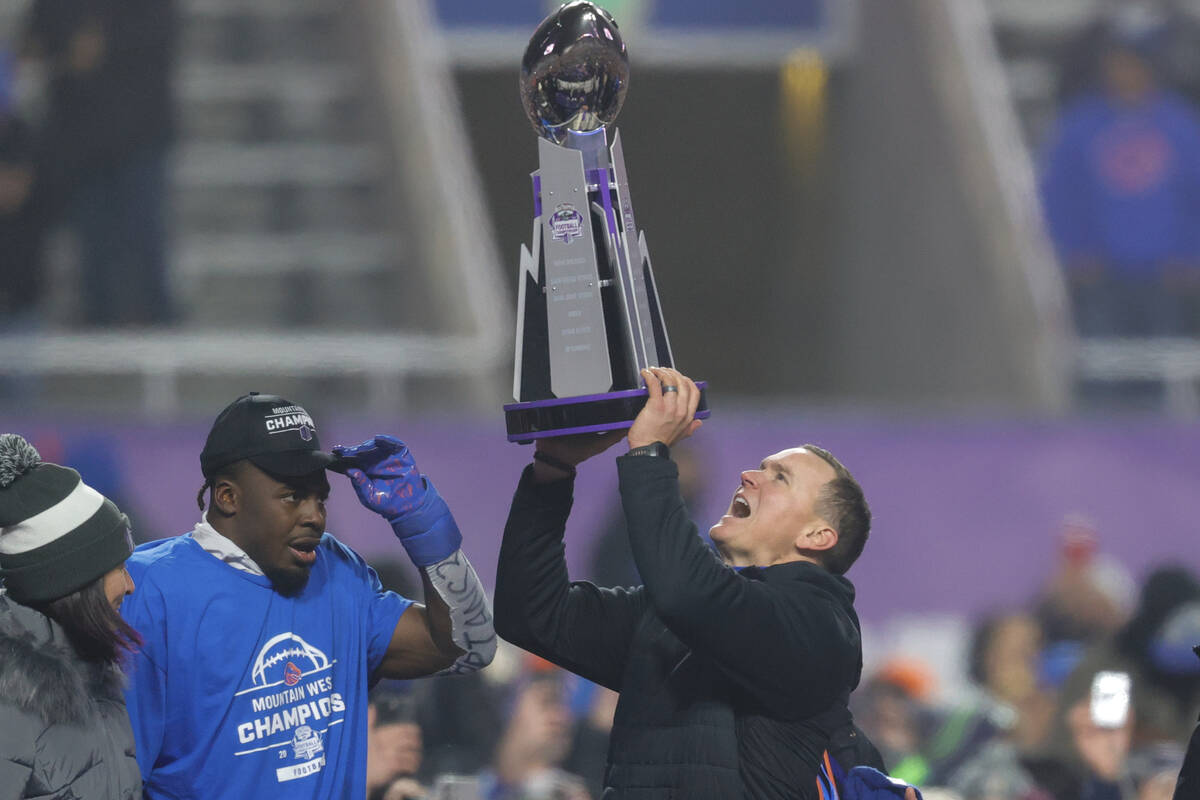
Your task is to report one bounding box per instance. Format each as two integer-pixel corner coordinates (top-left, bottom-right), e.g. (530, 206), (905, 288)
(367, 685), (427, 800)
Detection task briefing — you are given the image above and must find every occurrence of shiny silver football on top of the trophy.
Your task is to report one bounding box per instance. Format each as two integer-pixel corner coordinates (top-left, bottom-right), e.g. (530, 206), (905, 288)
(521, 0), (629, 144)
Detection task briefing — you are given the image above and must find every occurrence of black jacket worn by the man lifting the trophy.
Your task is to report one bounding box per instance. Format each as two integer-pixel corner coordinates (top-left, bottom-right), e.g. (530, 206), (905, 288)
(496, 456), (862, 799)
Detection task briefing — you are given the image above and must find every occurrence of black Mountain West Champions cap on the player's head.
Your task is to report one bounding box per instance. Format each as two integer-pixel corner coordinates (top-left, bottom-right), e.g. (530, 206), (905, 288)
(200, 392), (337, 477)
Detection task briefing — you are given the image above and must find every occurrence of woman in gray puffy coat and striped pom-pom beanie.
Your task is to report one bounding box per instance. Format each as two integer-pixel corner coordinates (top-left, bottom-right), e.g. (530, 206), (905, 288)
(0, 434), (142, 800)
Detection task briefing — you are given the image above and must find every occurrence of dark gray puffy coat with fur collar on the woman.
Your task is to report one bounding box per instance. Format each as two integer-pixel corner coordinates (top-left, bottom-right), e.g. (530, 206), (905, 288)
(0, 593), (142, 800)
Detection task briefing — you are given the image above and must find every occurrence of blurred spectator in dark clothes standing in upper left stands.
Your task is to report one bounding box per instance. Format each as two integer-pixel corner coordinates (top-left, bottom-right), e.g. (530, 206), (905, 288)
(22, 0), (176, 325)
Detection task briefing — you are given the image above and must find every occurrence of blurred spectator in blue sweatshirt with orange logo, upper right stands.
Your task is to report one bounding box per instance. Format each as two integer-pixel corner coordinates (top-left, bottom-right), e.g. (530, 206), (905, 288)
(1043, 32), (1200, 336)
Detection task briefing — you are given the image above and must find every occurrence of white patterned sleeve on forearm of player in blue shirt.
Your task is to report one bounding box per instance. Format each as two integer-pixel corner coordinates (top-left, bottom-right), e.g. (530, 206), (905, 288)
(422, 551), (496, 675)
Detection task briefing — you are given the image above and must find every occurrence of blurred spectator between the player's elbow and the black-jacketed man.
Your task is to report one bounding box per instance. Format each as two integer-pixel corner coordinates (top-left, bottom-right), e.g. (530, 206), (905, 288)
(479, 668), (589, 800)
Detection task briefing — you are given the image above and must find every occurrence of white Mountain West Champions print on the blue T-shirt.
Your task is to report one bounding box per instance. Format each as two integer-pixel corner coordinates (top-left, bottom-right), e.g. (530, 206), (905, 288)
(234, 631), (346, 783)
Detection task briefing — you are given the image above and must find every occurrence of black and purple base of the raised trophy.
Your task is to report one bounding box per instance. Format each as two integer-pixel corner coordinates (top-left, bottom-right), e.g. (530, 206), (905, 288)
(504, 380), (709, 445)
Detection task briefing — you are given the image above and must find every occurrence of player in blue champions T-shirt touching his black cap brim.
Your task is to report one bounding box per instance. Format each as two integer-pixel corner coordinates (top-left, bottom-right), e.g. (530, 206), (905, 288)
(122, 393), (496, 800)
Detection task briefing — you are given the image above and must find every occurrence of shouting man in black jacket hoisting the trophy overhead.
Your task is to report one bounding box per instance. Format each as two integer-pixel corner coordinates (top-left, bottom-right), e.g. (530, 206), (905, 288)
(496, 368), (883, 799)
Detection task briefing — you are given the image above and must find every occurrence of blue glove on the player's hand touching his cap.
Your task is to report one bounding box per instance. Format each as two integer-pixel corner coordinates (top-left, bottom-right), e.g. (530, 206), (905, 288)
(334, 435), (462, 566)
